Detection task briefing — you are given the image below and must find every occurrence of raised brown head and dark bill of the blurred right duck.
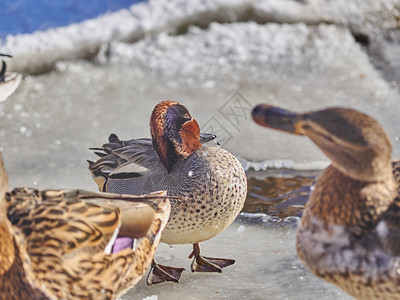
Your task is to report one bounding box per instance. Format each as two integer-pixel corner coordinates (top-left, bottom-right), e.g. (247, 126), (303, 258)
(252, 104), (392, 181)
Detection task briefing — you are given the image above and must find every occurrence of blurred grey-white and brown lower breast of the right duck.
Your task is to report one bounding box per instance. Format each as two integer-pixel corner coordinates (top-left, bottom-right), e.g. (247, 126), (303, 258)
(296, 217), (400, 299)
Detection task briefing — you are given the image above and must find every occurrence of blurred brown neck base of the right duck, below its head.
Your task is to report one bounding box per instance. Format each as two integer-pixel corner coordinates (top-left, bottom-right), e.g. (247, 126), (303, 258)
(302, 165), (396, 229)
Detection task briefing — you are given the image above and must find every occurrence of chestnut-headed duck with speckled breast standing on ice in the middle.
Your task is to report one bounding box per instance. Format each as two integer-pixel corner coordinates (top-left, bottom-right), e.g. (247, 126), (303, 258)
(89, 101), (247, 283)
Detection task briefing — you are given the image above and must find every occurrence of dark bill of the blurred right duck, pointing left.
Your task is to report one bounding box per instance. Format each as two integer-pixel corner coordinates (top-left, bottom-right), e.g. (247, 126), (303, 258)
(252, 104), (304, 135)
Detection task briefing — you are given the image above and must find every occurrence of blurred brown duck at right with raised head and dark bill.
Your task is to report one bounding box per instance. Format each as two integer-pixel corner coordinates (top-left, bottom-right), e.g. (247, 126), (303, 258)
(253, 105), (400, 299)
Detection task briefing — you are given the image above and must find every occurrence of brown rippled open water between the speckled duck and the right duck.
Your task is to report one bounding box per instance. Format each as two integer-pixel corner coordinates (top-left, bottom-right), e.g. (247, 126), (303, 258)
(242, 170), (320, 218)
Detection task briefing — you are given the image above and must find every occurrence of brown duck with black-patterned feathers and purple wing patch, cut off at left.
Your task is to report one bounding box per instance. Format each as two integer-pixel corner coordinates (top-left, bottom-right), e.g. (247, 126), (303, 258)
(0, 155), (170, 299)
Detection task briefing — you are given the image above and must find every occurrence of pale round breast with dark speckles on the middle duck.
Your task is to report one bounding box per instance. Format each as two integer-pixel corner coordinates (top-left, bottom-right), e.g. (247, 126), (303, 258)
(162, 147), (247, 244)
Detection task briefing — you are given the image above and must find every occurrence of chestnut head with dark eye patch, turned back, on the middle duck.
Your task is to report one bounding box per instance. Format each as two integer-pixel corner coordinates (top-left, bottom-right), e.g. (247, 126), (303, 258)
(150, 101), (201, 172)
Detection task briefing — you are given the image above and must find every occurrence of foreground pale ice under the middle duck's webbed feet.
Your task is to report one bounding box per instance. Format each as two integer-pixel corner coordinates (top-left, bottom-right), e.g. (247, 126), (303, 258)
(127, 222), (351, 300)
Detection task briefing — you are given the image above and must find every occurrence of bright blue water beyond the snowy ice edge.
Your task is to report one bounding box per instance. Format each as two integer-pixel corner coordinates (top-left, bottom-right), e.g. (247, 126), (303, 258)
(0, 0), (145, 39)
